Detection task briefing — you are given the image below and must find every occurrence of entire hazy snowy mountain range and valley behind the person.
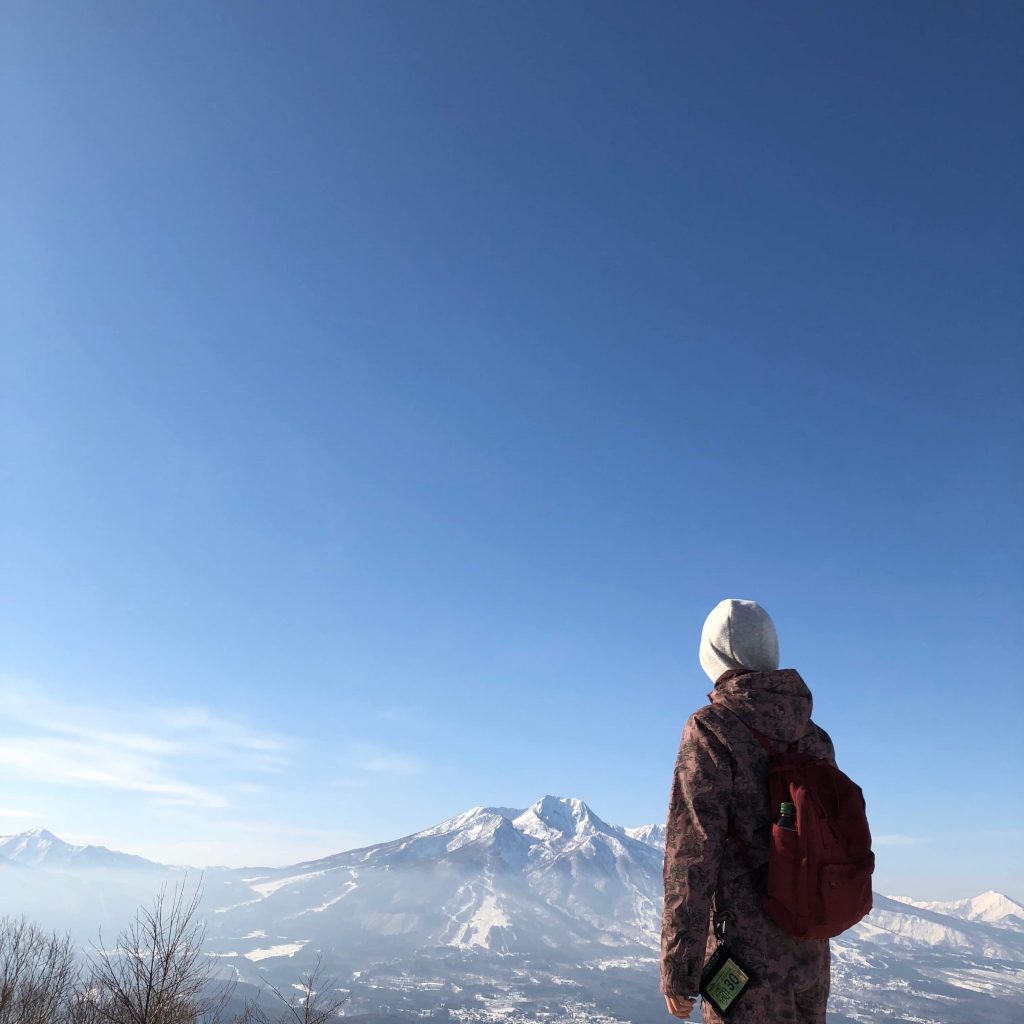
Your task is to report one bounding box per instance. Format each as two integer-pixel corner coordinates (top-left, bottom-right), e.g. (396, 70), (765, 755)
(0, 796), (1024, 1024)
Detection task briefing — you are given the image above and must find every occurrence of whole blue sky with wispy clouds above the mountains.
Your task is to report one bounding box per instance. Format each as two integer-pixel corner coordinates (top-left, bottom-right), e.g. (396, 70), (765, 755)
(0, 0), (1024, 898)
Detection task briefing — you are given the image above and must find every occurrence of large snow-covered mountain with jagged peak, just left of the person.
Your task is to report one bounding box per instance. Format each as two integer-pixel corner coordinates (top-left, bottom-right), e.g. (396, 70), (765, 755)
(199, 796), (662, 958)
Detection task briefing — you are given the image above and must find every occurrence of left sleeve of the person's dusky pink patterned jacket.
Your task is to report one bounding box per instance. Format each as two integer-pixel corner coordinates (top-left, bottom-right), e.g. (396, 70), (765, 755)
(660, 715), (732, 996)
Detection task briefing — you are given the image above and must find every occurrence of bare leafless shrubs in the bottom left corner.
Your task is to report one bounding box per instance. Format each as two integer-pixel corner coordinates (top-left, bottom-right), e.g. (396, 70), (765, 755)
(0, 883), (348, 1024)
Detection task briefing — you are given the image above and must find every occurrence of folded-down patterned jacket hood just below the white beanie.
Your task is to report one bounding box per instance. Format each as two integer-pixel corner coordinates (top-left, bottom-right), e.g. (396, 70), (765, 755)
(708, 669), (814, 743)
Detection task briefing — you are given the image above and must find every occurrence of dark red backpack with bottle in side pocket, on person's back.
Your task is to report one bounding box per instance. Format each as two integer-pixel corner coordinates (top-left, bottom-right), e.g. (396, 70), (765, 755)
(729, 715), (874, 939)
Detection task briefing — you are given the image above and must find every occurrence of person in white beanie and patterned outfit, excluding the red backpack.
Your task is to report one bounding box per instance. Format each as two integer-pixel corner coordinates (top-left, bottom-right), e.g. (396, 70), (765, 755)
(660, 598), (836, 1024)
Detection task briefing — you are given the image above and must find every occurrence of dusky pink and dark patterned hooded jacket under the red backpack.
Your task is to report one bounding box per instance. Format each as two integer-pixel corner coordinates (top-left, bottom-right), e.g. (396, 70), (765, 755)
(660, 669), (836, 999)
